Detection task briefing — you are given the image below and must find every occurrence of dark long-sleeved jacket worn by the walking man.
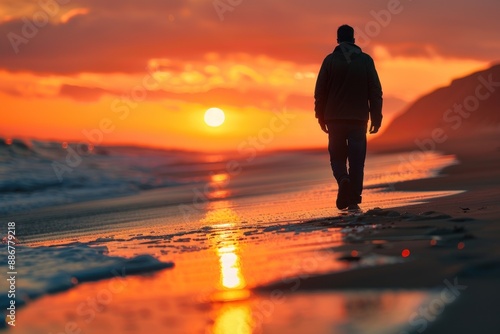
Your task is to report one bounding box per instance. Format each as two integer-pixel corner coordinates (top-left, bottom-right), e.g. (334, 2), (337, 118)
(314, 42), (382, 126)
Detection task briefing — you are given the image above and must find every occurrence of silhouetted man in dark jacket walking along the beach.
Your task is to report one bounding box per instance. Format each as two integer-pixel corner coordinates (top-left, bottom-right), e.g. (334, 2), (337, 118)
(314, 25), (382, 210)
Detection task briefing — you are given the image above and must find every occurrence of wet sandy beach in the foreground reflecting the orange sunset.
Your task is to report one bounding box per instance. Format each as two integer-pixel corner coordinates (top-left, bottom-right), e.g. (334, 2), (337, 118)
(2, 136), (500, 334)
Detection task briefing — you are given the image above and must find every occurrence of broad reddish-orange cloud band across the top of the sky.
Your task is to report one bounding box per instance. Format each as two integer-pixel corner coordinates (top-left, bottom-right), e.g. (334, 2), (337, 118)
(0, 0), (500, 74)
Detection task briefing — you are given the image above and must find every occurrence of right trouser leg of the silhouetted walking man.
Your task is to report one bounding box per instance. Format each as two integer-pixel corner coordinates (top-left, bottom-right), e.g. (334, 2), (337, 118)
(347, 124), (366, 204)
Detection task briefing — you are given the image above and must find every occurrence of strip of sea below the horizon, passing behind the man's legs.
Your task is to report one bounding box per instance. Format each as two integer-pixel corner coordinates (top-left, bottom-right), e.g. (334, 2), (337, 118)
(0, 139), (456, 215)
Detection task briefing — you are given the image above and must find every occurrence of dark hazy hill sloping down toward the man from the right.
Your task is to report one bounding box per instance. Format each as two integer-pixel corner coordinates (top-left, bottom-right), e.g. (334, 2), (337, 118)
(369, 65), (500, 152)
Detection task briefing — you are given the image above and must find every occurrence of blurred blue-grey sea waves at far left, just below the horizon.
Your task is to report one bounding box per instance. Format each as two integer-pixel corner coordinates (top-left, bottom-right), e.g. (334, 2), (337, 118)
(0, 139), (188, 214)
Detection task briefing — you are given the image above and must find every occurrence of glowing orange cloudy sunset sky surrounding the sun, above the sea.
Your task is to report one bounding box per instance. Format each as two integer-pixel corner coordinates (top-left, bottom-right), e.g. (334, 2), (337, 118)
(0, 0), (500, 151)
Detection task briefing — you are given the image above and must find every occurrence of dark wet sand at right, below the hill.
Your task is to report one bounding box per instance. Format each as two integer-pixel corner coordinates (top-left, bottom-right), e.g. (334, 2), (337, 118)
(260, 140), (500, 334)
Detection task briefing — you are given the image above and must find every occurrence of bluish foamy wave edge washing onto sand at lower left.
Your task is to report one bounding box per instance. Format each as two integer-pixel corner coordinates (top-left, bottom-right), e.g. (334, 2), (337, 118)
(0, 243), (174, 309)
